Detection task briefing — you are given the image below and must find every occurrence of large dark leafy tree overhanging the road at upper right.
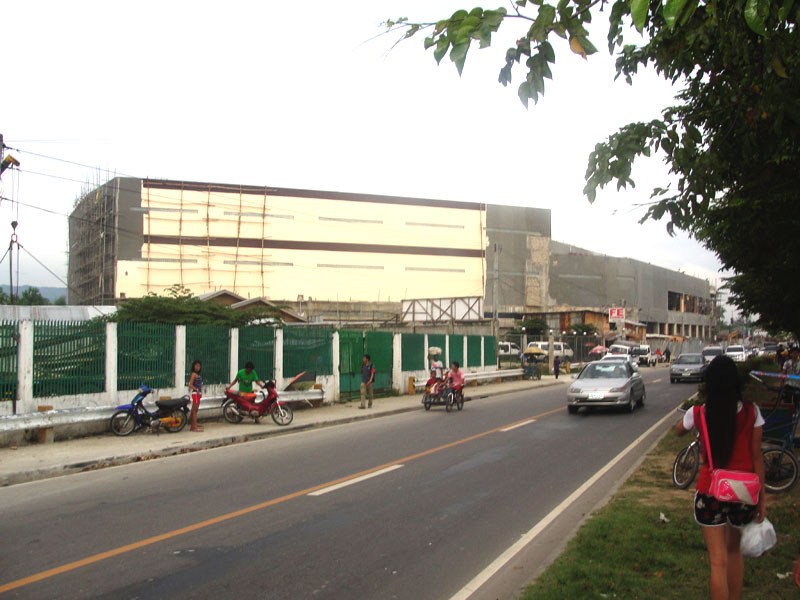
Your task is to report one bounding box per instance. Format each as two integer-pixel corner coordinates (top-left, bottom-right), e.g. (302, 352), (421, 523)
(387, 0), (800, 335)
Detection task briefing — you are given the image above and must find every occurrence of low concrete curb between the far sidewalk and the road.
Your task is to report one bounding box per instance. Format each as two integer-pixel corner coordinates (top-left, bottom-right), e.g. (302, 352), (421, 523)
(0, 381), (559, 487)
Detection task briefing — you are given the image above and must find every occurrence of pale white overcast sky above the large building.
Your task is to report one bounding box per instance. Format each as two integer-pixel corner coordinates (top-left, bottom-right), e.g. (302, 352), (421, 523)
(0, 0), (720, 304)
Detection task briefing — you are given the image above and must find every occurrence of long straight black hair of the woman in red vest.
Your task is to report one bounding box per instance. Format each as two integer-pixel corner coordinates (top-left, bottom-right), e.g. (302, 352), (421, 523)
(698, 355), (742, 469)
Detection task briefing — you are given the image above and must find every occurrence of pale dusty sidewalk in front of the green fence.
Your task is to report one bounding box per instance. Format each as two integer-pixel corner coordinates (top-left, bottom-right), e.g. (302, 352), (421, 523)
(0, 376), (569, 486)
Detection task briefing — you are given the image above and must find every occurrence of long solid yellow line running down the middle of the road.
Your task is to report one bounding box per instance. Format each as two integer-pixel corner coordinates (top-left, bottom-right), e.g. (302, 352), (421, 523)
(0, 407), (564, 594)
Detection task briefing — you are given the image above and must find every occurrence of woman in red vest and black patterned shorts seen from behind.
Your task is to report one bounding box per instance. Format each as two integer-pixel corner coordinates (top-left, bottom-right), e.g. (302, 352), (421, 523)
(675, 355), (767, 600)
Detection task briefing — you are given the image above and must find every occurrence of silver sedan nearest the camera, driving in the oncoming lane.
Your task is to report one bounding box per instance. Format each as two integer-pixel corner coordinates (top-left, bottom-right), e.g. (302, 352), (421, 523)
(567, 360), (646, 415)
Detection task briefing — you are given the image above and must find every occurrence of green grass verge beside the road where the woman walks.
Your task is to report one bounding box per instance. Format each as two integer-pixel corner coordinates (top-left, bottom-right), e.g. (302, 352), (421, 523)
(521, 424), (800, 600)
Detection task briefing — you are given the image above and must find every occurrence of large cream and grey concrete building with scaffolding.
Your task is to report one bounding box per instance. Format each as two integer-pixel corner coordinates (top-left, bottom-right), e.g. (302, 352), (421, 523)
(69, 178), (711, 337)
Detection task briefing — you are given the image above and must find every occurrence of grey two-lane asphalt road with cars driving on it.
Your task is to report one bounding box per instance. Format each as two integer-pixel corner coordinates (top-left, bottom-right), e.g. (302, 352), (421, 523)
(0, 369), (695, 600)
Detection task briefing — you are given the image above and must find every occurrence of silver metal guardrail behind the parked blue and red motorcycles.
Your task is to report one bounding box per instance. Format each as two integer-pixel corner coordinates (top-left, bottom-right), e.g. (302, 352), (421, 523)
(0, 390), (324, 434)
